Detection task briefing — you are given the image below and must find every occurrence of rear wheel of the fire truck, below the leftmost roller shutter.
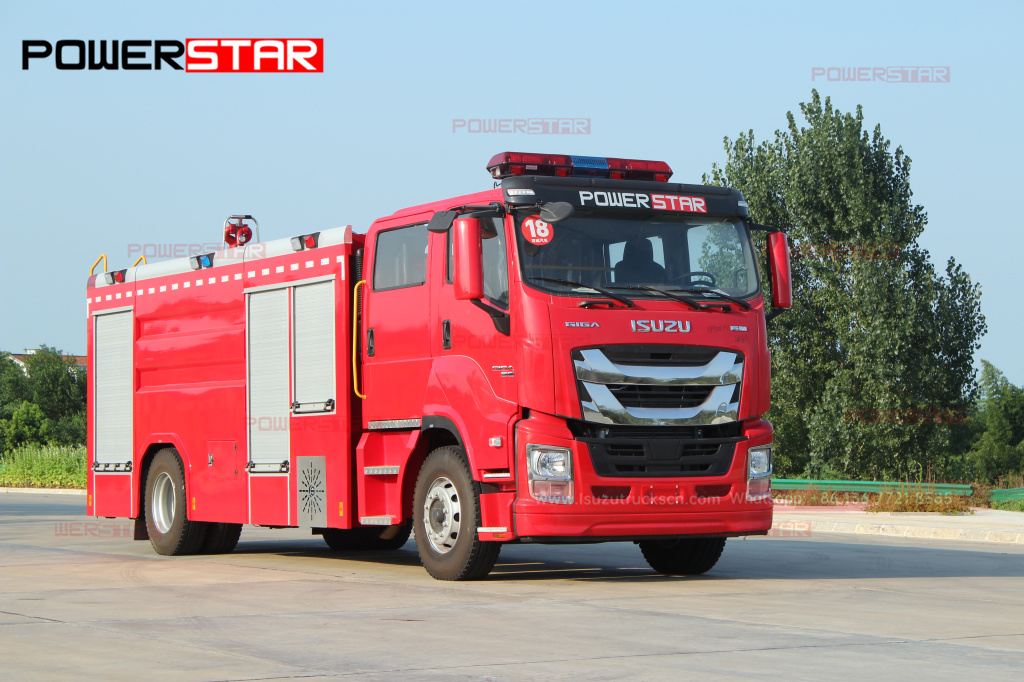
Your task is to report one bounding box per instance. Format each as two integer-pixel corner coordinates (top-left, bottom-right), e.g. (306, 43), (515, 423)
(145, 447), (207, 556)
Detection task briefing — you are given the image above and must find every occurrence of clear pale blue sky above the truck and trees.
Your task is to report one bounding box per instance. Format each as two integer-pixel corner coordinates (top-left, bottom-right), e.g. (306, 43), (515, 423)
(0, 0), (1024, 385)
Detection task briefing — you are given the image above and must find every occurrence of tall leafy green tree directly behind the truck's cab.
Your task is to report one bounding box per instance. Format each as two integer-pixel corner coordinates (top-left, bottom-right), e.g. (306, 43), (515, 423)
(705, 91), (986, 478)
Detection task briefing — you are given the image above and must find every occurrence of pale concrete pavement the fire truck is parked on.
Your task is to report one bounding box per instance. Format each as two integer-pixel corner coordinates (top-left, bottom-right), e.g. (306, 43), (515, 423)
(6, 495), (1024, 681)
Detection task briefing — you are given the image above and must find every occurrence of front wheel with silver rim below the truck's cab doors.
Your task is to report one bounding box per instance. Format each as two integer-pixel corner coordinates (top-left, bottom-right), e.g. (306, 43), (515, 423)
(413, 445), (502, 581)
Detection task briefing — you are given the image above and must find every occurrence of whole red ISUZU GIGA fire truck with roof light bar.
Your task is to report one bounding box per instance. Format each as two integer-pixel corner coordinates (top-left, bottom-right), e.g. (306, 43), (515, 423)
(88, 153), (792, 580)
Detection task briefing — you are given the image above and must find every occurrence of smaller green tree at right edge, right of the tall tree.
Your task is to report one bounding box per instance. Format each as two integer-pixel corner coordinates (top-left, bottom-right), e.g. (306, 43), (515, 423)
(970, 360), (1024, 480)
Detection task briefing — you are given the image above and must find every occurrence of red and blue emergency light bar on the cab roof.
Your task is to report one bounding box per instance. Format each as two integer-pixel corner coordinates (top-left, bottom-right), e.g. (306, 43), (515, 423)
(487, 152), (672, 182)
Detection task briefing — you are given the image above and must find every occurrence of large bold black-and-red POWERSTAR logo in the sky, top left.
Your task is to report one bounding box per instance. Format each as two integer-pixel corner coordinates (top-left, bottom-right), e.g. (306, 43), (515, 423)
(22, 38), (324, 74)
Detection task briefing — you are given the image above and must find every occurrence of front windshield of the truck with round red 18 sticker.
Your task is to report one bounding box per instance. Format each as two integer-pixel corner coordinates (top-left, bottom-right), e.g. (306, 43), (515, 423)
(515, 208), (758, 298)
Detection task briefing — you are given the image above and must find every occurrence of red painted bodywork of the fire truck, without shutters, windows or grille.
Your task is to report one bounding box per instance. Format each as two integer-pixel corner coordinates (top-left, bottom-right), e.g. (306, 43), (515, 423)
(88, 175), (784, 542)
